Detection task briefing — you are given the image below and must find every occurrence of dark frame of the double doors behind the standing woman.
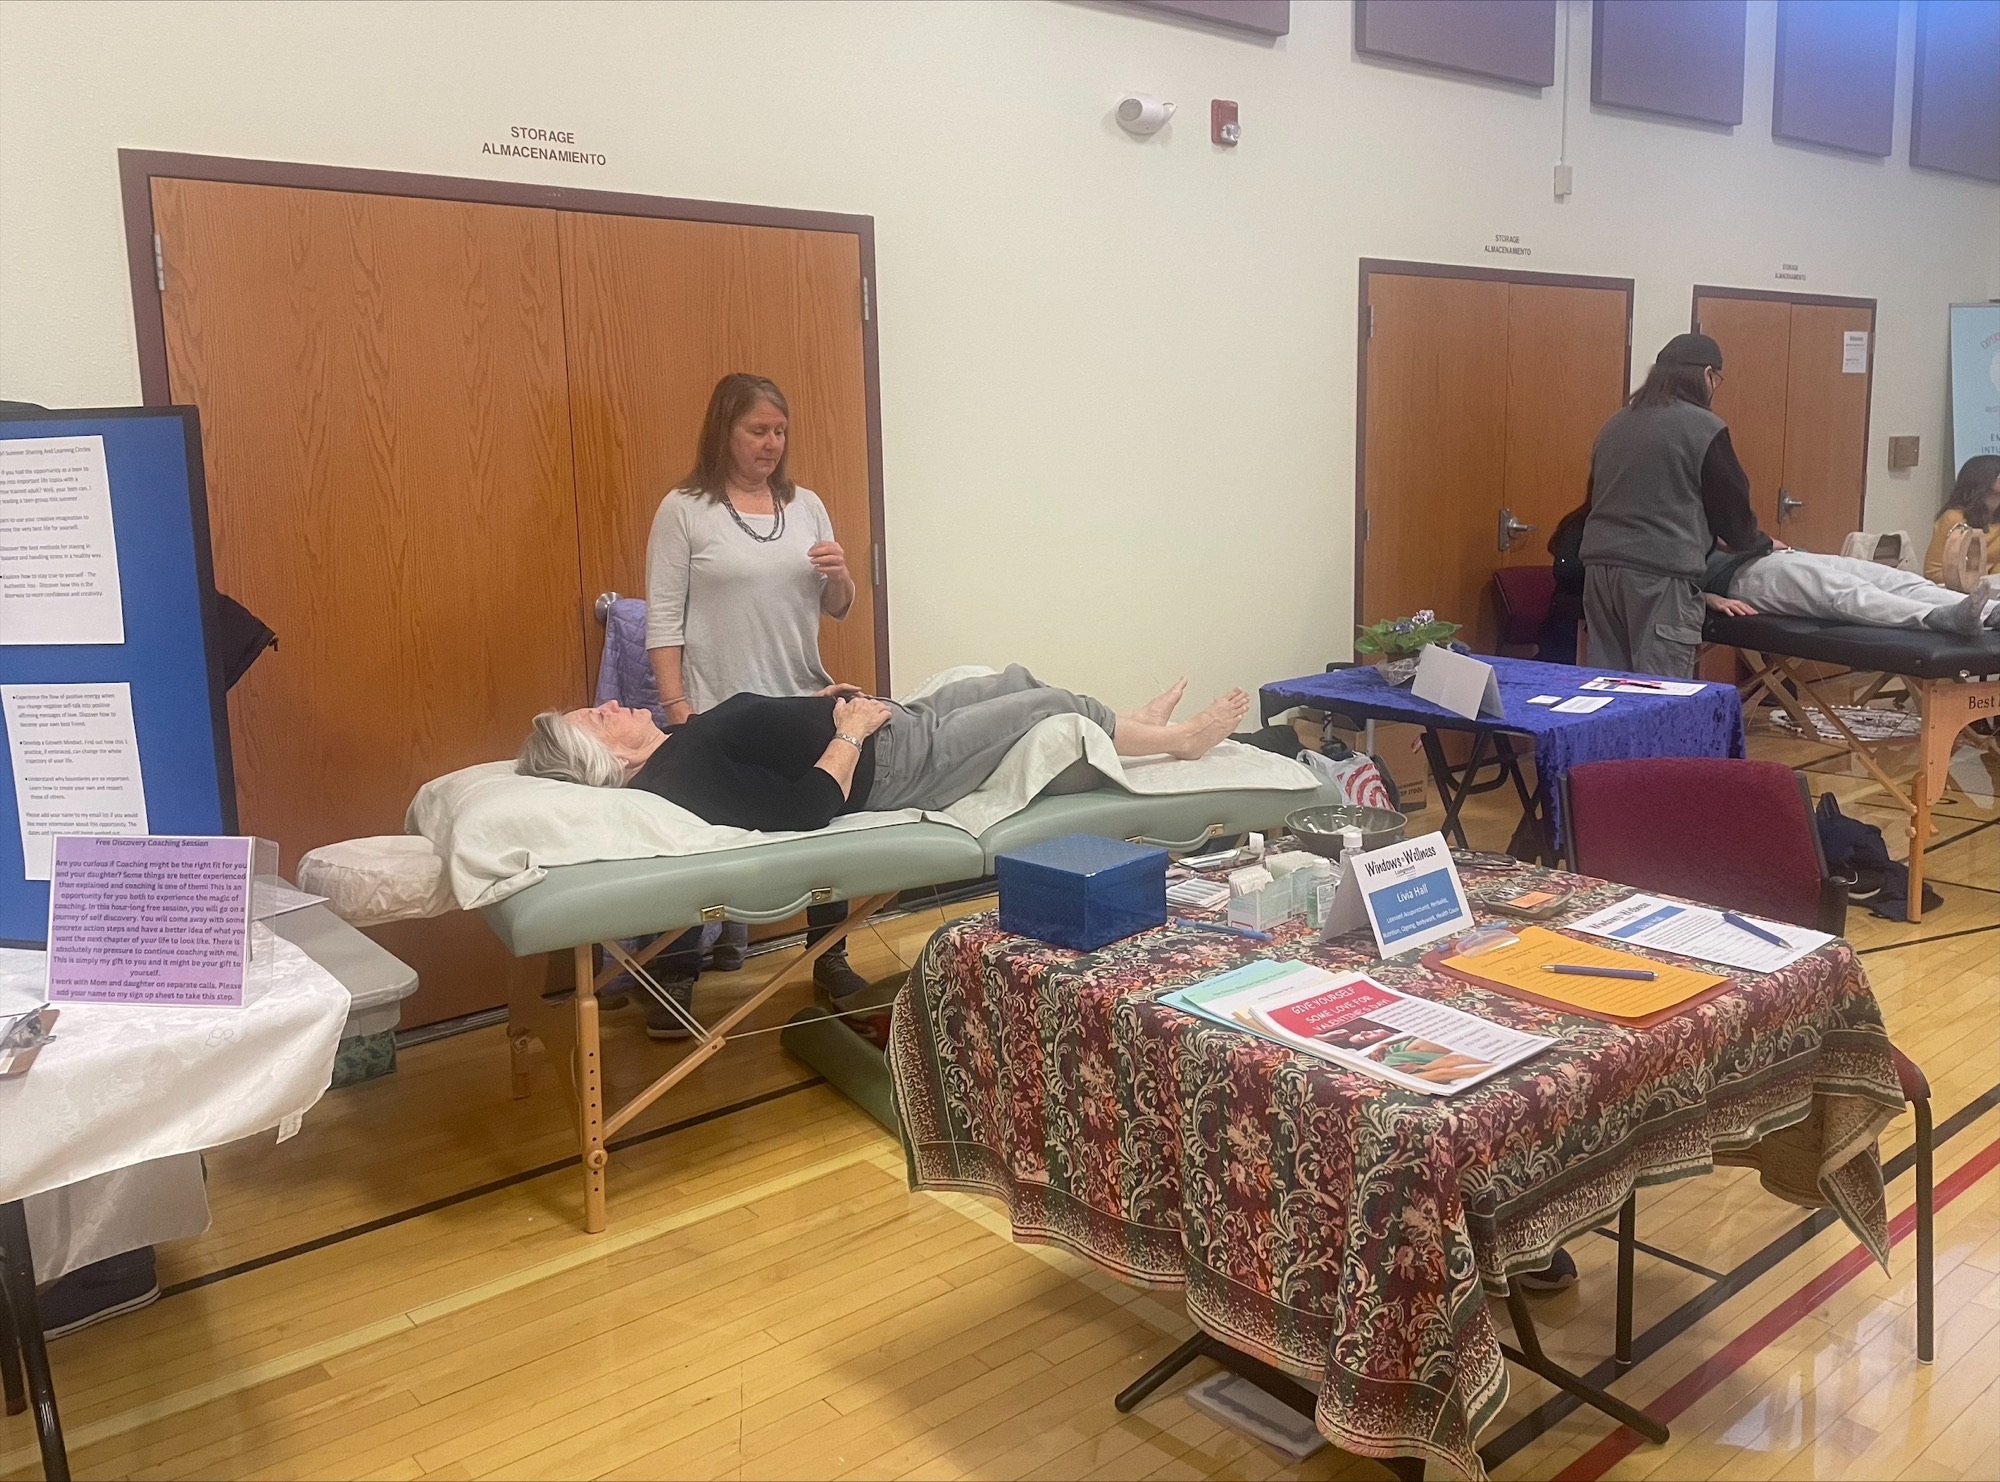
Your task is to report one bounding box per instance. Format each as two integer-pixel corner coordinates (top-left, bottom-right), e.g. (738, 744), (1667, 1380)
(118, 150), (892, 694)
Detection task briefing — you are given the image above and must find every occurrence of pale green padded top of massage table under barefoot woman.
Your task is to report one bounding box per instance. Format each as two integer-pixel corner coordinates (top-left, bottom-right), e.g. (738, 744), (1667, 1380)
(484, 784), (1342, 958)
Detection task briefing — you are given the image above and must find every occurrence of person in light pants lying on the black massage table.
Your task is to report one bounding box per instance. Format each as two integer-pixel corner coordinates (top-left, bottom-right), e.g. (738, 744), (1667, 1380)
(1702, 546), (2000, 636)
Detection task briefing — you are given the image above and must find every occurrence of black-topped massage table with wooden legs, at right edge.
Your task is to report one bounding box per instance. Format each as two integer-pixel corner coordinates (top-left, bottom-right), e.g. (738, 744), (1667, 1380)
(1702, 614), (2000, 922)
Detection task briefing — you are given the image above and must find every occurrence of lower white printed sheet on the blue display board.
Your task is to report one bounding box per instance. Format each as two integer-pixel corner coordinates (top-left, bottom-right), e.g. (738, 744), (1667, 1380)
(0, 684), (150, 880)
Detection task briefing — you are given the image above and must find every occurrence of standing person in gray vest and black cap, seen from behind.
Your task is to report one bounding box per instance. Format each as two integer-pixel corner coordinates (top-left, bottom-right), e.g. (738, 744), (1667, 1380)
(1582, 334), (1774, 680)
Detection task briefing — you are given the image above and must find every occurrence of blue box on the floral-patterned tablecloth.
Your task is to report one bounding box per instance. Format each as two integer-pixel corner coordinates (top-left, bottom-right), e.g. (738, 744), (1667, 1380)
(994, 834), (1166, 952)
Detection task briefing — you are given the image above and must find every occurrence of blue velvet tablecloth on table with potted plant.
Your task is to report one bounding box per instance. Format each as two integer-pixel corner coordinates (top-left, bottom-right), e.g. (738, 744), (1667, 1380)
(1262, 654), (1744, 844)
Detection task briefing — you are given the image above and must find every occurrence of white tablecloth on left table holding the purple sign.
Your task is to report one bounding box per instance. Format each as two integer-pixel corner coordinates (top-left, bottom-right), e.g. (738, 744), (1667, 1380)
(0, 926), (350, 1202)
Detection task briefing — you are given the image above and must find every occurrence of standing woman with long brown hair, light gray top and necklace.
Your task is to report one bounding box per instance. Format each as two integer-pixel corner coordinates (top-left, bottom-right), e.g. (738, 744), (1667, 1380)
(646, 374), (866, 1038)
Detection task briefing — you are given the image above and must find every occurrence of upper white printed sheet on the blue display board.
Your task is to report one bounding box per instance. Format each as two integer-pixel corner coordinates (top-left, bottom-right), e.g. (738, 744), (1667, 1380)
(0, 436), (124, 644)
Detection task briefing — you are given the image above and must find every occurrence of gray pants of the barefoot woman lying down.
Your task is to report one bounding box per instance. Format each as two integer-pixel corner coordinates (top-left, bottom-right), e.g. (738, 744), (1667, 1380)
(868, 664), (1118, 812)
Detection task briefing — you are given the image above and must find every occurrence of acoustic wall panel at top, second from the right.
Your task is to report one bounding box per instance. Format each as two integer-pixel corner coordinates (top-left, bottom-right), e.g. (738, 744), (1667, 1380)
(1770, 0), (1898, 160)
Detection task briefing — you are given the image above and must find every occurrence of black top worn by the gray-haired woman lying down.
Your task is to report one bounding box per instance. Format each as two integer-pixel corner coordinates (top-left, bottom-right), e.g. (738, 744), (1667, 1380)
(626, 694), (874, 830)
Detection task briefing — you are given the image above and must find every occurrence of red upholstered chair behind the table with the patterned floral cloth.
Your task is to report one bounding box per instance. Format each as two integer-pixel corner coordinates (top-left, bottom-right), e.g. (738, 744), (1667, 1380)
(1562, 756), (1934, 1364)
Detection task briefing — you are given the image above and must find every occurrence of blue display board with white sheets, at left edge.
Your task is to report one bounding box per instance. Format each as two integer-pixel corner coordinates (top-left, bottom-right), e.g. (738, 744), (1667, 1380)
(0, 406), (236, 946)
